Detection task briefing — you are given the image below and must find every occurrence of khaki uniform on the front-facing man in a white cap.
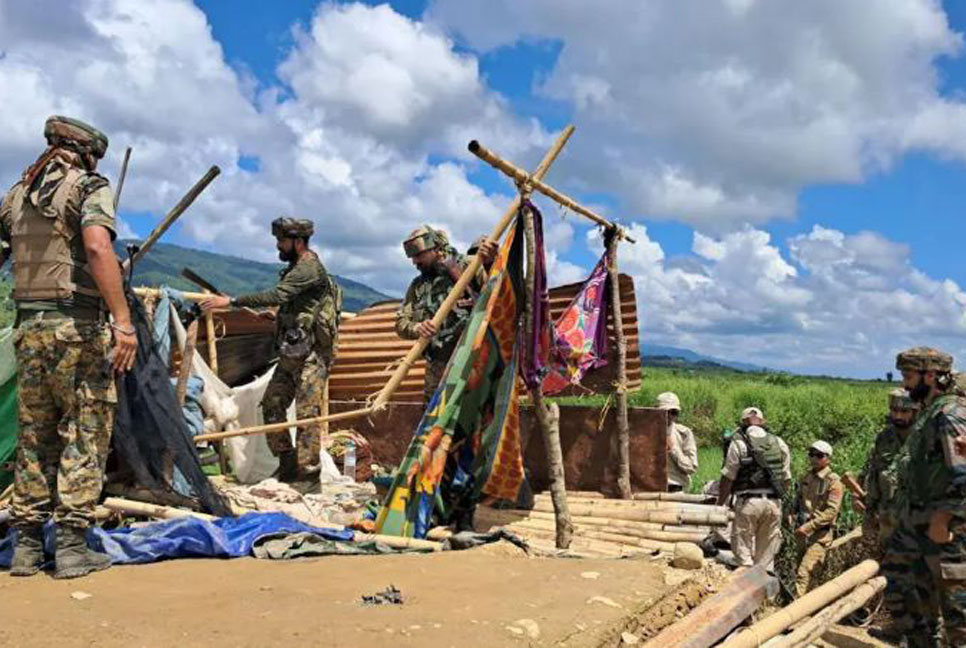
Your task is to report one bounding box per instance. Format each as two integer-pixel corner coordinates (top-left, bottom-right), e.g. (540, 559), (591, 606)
(795, 466), (844, 596)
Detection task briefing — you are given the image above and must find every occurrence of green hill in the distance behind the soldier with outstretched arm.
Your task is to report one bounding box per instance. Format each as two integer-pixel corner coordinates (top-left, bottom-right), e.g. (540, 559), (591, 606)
(114, 240), (393, 312)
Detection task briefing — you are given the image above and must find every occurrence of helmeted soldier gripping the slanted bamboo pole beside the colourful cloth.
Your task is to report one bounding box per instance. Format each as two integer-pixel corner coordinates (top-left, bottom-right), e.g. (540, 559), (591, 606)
(396, 225), (496, 405)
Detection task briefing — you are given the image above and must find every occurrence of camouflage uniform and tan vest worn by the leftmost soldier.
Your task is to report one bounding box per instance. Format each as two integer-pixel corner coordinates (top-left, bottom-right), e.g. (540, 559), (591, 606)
(0, 125), (117, 530)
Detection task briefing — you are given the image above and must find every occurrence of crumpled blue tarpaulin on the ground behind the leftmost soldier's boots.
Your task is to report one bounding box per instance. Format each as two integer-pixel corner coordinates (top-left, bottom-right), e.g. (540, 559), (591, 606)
(0, 512), (353, 567)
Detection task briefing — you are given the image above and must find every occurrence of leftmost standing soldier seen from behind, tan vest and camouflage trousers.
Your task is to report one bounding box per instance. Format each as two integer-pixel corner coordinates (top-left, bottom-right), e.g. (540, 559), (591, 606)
(0, 116), (137, 578)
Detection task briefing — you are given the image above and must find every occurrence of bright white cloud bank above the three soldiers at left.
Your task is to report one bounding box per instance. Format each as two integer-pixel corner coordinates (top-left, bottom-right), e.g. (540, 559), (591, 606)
(0, 0), (551, 292)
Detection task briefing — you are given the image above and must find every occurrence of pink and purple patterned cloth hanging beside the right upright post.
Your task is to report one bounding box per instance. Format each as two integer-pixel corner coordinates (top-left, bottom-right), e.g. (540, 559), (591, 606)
(543, 252), (609, 395)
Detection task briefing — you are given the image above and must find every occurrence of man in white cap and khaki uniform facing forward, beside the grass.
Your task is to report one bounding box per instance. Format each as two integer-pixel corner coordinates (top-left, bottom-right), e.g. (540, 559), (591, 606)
(795, 441), (845, 597)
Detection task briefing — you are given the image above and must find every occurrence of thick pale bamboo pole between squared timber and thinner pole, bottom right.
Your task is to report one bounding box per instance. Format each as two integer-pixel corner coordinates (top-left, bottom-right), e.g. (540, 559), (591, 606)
(720, 560), (879, 648)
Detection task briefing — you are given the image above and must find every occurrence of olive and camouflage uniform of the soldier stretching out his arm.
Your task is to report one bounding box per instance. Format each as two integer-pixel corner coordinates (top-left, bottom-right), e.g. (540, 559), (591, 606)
(233, 251), (341, 473)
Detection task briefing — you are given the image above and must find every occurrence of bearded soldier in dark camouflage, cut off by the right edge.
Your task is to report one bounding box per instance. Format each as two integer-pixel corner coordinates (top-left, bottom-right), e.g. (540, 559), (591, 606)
(880, 347), (966, 646)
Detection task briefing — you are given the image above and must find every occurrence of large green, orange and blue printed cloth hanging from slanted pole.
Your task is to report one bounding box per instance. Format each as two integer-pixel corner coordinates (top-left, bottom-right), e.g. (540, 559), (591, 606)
(376, 218), (524, 538)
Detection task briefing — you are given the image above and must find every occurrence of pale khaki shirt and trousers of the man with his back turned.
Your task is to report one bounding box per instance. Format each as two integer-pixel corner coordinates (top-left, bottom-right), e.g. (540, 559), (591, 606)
(721, 429), (791, 570)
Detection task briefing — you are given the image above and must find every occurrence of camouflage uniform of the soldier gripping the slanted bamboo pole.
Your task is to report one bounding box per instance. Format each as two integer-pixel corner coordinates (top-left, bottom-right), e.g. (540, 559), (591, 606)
(396, 226), (486, 405)
